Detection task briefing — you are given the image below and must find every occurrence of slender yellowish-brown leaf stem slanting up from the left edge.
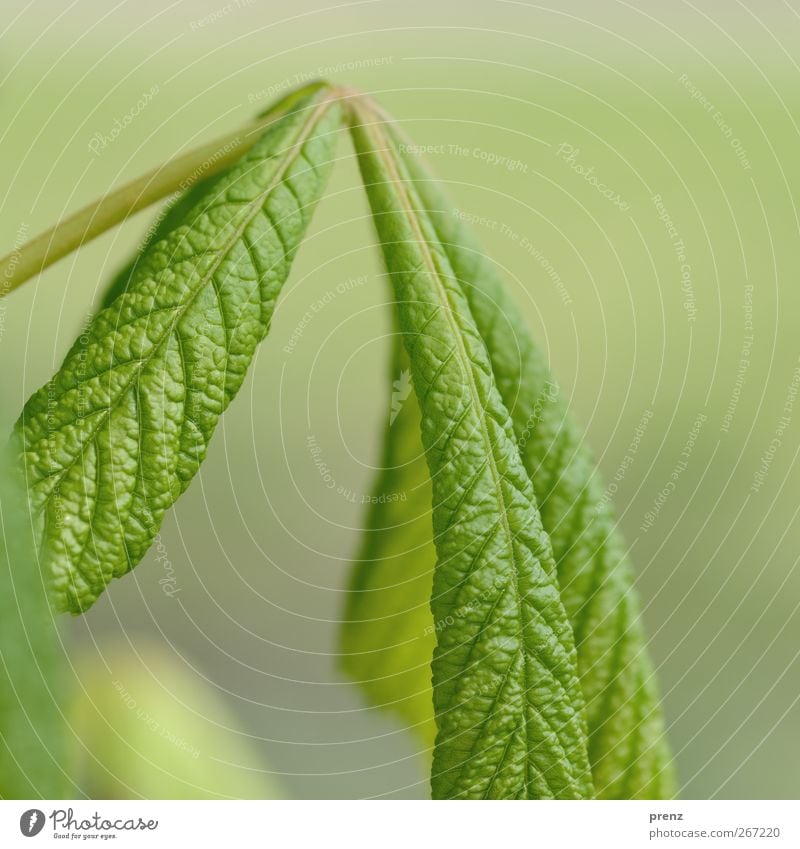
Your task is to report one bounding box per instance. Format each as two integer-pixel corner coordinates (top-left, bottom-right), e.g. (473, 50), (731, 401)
(0, 84), (332, 298)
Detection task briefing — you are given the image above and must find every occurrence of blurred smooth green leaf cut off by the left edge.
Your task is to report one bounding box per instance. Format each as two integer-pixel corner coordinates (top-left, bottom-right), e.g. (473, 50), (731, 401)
(0, 434), (67, 799)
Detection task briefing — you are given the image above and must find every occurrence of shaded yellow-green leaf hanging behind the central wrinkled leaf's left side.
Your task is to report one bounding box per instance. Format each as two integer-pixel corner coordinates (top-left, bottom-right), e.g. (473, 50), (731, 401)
(340, 337), (436, 747)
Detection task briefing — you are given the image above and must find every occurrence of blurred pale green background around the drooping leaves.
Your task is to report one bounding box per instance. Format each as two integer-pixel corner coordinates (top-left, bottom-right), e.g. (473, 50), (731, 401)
(0, 0), (800, 798)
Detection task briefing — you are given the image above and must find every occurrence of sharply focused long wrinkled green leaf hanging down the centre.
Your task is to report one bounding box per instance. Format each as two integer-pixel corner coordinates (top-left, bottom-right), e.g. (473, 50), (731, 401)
(352, 105), (592, 798)
